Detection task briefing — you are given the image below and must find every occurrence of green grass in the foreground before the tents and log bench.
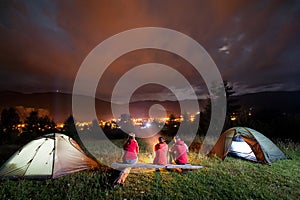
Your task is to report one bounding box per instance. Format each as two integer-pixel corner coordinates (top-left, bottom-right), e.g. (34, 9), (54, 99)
(0, 141), (300, 199)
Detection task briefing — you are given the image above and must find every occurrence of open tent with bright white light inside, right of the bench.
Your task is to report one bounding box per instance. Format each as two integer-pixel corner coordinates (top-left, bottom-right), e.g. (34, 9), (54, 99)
(209, 127), (286, 164)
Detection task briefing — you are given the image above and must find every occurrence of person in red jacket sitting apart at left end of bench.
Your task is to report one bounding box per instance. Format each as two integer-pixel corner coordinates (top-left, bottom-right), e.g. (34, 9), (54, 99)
(123, 133), (139, 164)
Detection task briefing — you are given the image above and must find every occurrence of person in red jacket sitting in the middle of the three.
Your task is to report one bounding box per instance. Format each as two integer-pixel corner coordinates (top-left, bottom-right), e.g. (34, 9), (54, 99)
(153, 137), (168, 165)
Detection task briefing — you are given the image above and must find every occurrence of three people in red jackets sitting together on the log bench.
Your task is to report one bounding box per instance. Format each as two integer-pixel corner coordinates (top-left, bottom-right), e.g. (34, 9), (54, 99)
(123, 133), (188, 165)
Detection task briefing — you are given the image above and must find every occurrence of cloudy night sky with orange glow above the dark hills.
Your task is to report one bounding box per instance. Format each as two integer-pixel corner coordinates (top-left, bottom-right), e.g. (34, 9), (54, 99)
(0, 0), (300, 103)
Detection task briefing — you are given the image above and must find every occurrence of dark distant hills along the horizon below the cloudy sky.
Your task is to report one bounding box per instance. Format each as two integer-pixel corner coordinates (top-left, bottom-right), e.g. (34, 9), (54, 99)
(0, 91), (300, 122)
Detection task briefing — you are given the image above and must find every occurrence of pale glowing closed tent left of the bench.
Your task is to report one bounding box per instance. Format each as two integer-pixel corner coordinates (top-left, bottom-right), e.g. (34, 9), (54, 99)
(0, 133), (98, 179)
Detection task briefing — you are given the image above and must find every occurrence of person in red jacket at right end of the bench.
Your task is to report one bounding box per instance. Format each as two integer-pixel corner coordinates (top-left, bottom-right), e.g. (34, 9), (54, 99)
(170, 136), (188, 165)
